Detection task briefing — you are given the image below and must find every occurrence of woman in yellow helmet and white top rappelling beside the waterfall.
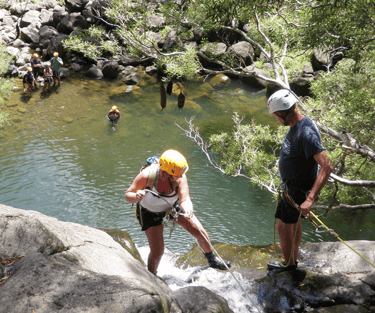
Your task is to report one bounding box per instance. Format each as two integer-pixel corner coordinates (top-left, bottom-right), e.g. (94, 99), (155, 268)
(125, 150), (230, 274)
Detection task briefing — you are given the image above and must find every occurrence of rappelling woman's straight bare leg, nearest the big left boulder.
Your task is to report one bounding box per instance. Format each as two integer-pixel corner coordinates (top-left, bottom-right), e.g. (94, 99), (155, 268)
(145, 225), (164, 274)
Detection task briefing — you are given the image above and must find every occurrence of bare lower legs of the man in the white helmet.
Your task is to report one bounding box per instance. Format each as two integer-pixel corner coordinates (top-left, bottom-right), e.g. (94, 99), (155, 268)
(277, 220), (302, 265)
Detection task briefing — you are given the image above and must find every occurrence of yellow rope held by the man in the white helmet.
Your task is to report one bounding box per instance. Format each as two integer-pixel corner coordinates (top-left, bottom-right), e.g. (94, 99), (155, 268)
(273, 184), (375, 268)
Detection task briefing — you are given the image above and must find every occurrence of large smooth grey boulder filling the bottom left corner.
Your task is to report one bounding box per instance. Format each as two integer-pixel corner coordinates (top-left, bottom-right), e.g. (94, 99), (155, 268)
(0, 205), (231, 313)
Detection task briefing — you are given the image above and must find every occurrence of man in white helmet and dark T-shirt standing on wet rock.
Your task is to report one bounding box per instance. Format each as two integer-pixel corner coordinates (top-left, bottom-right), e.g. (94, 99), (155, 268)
(267, 89), (333, 271)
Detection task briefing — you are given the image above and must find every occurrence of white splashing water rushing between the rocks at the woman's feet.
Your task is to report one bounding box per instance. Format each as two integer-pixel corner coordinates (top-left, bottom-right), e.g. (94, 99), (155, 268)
(138, 246), (259, 313)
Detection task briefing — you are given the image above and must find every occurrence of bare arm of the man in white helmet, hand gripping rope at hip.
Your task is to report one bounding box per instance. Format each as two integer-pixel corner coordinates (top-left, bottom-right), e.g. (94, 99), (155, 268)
(300, 151), (333, 215)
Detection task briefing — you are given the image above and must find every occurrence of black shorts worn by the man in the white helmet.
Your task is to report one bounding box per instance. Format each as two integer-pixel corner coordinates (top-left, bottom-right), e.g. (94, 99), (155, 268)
(275, 184), (308, 224)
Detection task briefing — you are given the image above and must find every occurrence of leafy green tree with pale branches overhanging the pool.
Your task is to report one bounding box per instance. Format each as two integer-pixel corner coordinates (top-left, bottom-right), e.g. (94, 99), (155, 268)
(67, 0), (375, 209)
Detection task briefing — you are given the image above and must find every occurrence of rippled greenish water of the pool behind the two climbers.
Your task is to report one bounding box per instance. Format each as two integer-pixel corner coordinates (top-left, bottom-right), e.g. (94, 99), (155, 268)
(0, 70), (375, 312)
